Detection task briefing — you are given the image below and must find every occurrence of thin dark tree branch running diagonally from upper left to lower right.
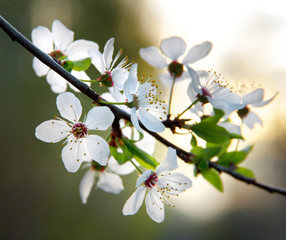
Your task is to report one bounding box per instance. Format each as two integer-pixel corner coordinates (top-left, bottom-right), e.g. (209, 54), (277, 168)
(0, 15), (286, 196)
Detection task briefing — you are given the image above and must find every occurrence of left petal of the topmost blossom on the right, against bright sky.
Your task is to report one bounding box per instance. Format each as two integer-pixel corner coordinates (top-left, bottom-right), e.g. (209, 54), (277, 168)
(139, 46), (168, 69)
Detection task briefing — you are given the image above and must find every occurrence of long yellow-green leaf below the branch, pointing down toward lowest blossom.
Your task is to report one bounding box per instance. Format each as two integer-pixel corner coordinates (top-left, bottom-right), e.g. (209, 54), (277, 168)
(121, 137), (159, 169)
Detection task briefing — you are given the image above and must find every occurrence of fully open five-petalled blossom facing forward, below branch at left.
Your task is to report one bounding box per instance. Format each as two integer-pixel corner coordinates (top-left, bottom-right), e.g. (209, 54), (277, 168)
(36, 92), (114, 172)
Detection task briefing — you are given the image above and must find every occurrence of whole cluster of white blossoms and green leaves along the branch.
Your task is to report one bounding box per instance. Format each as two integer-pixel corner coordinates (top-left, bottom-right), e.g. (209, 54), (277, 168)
(32, 20), (276, 222)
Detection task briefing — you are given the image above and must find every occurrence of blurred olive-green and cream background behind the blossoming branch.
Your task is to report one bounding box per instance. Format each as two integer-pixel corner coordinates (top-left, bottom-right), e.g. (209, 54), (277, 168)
(0, 0), (286, 240)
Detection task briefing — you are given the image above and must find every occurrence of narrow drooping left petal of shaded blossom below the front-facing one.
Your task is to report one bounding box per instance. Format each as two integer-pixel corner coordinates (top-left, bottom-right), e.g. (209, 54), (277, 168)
(79, 168), (96, 204)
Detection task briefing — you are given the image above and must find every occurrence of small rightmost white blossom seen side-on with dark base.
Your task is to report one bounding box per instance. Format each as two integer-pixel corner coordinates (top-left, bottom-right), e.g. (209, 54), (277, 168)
(237, 88), (277, 129)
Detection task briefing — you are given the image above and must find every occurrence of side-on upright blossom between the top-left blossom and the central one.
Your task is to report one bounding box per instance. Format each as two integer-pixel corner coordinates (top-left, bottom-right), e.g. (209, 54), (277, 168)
(88, 38), (129, 98)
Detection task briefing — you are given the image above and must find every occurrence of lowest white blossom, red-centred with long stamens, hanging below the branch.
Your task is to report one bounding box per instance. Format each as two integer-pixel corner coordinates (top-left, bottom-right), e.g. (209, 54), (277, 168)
(122, 147), (192, 223)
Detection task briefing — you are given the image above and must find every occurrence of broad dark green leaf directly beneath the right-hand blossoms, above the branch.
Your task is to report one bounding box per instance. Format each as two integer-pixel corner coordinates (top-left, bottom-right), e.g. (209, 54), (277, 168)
(190, 121), (230, 143)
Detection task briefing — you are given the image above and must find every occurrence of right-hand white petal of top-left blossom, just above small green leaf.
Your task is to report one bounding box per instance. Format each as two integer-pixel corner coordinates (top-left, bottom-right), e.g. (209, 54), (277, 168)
(66, 39), (98, 61)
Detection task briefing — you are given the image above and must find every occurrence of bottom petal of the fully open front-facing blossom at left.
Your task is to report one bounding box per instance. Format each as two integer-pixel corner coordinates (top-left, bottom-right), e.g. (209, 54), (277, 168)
(62, 141), (87, 172)
